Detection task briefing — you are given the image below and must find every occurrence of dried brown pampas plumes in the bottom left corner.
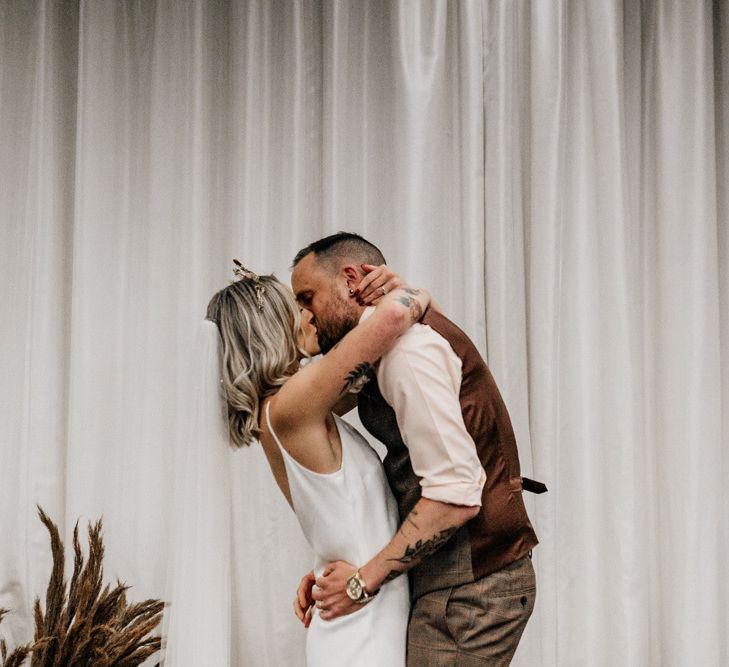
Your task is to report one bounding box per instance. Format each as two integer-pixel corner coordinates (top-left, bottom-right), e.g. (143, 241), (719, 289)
(0, 507), (164, 667)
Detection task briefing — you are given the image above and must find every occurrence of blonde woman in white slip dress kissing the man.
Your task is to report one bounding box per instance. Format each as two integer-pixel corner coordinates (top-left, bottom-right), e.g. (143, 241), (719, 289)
(202, 265), (430, 667)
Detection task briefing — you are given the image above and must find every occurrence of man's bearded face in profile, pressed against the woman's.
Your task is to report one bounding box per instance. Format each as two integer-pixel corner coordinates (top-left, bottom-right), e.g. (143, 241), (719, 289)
(291, 253), (361, 354)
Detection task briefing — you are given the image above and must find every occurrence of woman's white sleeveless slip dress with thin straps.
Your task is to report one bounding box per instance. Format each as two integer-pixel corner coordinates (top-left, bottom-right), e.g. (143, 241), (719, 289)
(266, 404), (410, 667)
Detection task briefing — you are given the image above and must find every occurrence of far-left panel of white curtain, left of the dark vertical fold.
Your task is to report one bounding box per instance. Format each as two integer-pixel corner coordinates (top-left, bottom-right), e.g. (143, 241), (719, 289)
(0, 3), (79, 638)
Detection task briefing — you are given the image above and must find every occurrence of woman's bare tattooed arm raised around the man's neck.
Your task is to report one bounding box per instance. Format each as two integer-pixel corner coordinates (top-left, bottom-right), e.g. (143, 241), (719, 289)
(275, 287), (430, 428)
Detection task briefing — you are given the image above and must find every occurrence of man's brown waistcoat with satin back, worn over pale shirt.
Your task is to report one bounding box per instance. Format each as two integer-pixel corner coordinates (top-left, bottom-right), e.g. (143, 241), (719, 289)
(358, 310), (537, 598)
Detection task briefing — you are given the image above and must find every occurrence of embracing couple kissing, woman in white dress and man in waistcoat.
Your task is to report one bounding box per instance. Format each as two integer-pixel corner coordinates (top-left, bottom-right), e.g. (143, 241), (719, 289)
(206, 232), (543, 667)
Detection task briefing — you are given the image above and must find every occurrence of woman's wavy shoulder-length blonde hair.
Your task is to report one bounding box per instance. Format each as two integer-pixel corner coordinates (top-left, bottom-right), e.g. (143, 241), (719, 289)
(206, 275), (305, 447)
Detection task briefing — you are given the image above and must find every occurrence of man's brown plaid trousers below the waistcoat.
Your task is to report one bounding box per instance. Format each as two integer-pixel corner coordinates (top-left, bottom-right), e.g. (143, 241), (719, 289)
(407, 556), (536, 667)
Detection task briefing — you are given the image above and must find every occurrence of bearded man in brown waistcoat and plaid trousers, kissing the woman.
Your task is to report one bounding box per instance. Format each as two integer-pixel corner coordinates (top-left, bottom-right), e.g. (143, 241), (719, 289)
(291, 232), (546, 667)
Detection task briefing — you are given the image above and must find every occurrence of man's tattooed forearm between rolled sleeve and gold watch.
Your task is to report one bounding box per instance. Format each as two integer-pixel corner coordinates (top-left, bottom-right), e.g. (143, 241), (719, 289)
(360, 498), (480, 592)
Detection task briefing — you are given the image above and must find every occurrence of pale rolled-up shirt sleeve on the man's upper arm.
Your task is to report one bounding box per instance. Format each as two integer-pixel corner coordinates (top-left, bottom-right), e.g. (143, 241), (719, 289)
(377, 324), (486, 506)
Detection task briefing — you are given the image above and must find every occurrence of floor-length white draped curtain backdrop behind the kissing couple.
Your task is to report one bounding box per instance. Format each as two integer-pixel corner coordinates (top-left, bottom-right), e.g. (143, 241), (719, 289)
(0, 0), (729, 667)
